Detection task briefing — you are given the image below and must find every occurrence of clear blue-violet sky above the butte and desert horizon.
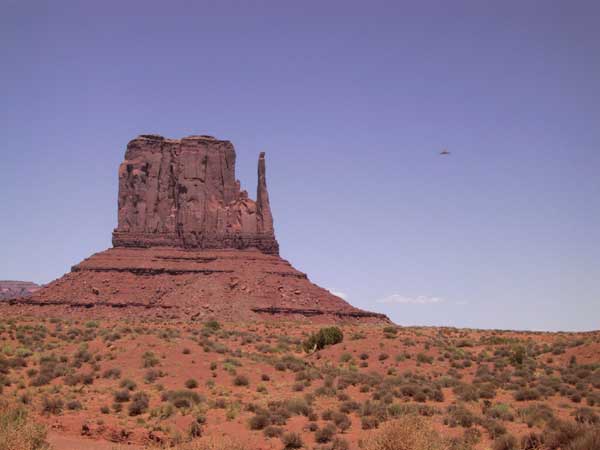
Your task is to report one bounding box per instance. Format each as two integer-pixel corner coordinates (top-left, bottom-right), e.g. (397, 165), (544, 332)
(0, 0), (600, 330)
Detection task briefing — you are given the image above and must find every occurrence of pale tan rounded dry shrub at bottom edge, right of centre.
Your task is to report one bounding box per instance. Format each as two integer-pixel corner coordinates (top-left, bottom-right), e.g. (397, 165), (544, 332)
(363, 416), (448, 450)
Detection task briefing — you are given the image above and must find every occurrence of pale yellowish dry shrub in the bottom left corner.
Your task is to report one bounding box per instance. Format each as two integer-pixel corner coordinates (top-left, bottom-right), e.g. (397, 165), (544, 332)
(0, 399), (49, 450)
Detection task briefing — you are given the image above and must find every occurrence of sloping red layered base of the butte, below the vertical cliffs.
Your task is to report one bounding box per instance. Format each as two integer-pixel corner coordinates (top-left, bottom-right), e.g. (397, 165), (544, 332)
(19, 247), (385, 321)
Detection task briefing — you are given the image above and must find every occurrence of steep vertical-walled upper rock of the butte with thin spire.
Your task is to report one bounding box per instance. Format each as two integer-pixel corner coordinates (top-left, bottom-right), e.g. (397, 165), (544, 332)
(113, 135), (279, 254)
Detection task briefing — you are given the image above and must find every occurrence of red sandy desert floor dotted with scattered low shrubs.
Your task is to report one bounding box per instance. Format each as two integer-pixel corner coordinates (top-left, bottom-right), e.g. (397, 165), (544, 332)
(0, 317), (600, 450)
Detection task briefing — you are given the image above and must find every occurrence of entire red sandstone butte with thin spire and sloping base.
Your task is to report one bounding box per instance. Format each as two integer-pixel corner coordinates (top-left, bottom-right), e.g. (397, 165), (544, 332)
(7, 135), (388, 322)
